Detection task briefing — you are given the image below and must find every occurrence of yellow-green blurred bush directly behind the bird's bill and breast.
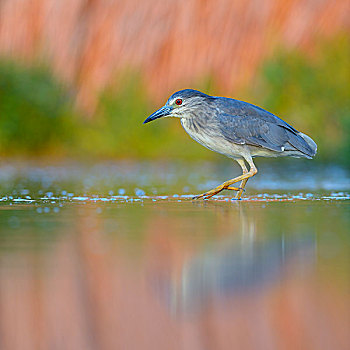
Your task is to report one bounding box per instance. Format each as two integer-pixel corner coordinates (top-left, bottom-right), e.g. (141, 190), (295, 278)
(81, 73), (214, 159)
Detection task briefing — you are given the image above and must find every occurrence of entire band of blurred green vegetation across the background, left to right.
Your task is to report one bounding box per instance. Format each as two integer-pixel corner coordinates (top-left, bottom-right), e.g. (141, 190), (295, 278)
(0, 36), (350, 165)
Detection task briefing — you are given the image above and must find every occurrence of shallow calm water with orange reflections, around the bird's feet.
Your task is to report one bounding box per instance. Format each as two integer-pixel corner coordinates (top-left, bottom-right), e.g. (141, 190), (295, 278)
(0, 162), (350, 350)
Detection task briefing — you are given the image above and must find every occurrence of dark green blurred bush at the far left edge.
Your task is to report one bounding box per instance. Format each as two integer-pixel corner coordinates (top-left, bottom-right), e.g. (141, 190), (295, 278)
(0, 61), (74, 155)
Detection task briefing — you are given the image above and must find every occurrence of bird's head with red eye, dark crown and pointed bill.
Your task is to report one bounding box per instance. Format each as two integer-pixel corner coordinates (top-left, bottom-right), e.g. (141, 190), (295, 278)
(143, 89), (212, 124)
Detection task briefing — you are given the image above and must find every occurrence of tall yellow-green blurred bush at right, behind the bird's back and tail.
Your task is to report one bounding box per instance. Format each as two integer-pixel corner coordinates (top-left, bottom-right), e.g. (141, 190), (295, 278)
(243, 36), (350, 164)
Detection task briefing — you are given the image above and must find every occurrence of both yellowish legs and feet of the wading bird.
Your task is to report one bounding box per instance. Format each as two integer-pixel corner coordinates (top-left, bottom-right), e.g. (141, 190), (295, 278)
(193, 157), (258, 199)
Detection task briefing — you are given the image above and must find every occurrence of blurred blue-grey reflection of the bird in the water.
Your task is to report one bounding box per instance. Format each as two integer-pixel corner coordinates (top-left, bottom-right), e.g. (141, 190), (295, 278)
(162, 208), (316, 316)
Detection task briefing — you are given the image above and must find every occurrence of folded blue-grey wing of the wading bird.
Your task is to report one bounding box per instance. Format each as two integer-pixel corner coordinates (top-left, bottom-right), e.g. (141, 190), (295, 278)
(217, 99), (313, 155)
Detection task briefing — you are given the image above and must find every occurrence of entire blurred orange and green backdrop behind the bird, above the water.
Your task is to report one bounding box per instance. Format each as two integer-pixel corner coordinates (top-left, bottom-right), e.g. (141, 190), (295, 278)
(0, 0), (350, 166)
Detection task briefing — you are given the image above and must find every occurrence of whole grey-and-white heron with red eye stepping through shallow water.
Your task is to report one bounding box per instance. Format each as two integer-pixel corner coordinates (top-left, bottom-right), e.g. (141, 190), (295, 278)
(143, 89), (317, 200)
